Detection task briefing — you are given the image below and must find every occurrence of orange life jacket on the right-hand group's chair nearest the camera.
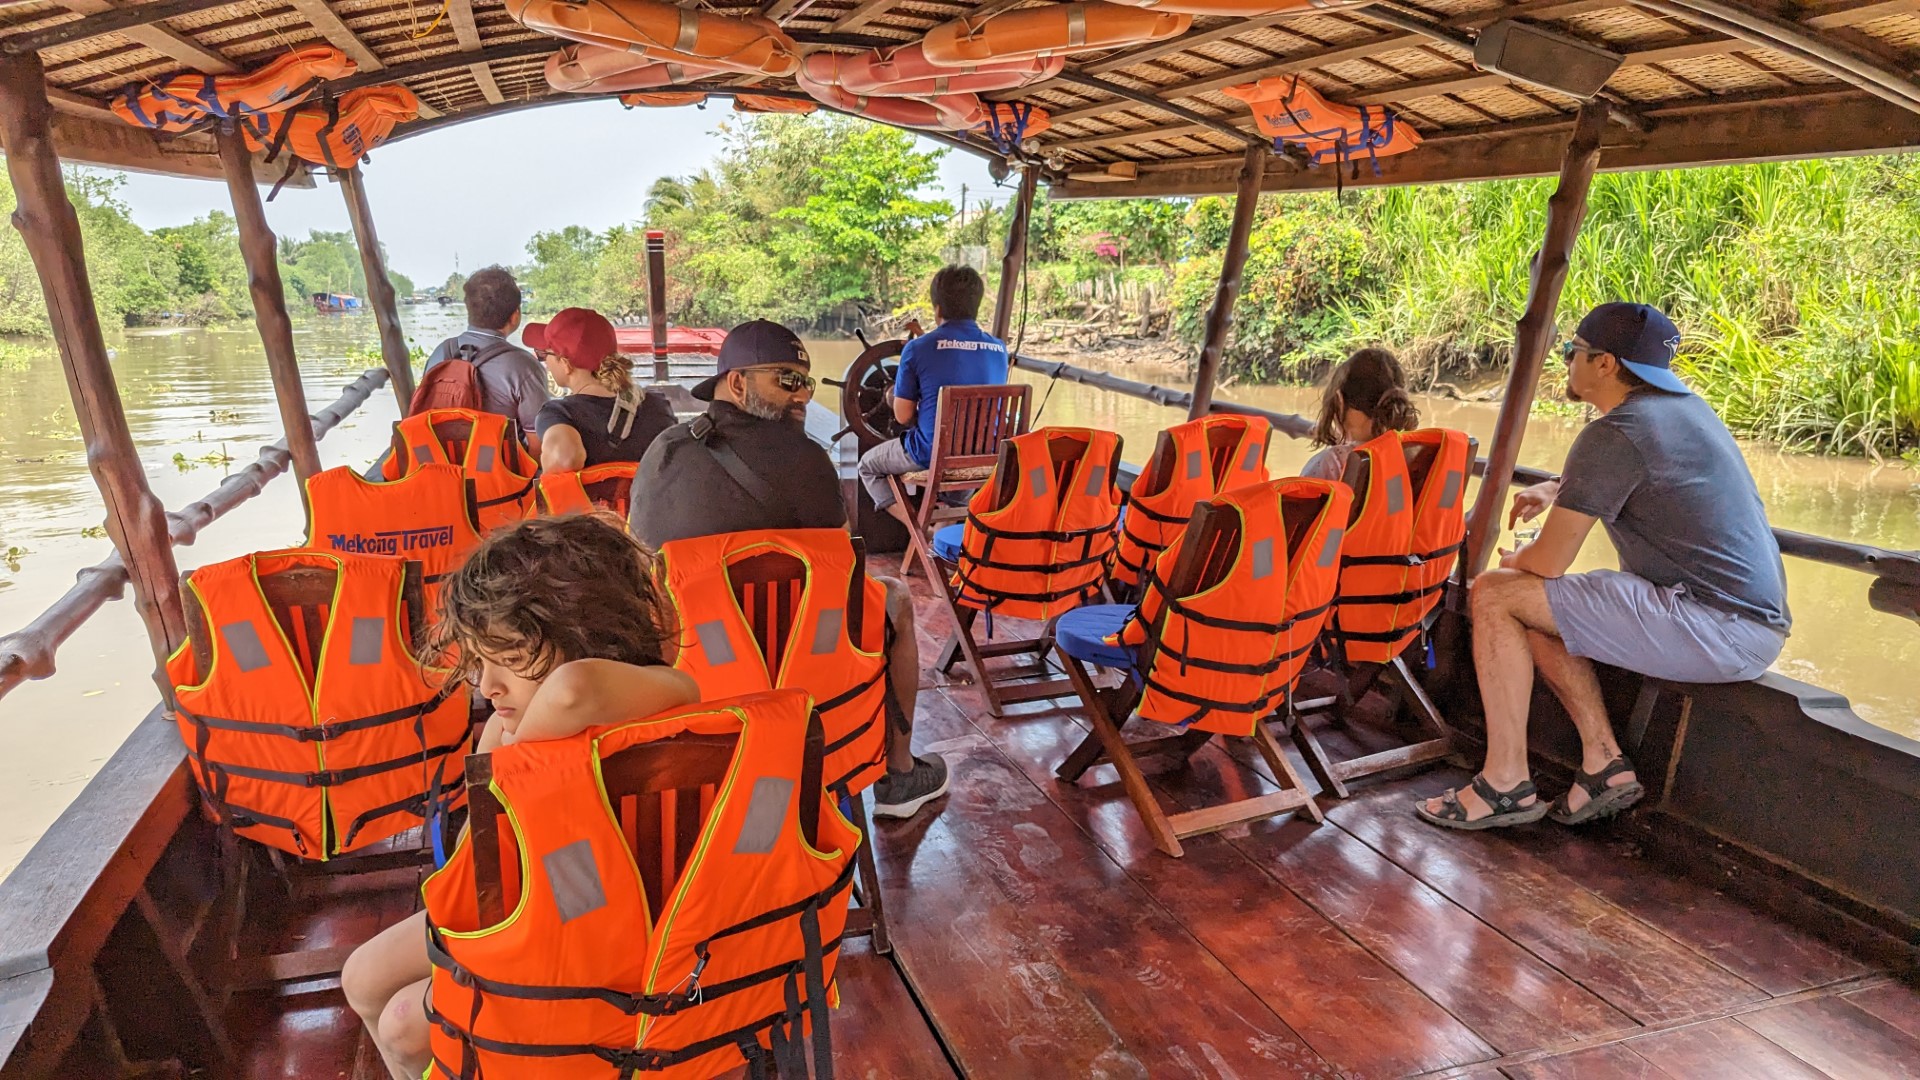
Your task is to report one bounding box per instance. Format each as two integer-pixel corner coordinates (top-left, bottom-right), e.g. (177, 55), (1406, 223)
(1116, 477), (1354, 736)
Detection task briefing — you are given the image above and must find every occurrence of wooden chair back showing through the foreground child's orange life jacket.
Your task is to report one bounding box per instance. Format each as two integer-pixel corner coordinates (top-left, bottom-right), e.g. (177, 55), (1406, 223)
(467, 715), (826, 926)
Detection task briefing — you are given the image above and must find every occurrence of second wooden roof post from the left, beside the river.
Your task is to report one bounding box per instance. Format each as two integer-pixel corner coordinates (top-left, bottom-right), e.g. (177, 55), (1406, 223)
(213, 131), (321, 491)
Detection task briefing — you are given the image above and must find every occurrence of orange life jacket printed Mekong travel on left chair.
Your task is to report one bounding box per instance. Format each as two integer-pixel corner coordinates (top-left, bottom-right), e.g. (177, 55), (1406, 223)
(307, 465), (480, 621)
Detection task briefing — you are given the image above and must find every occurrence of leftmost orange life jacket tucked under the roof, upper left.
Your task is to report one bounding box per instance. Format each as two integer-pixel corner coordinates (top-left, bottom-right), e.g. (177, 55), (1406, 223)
(108, 44), (357, 133)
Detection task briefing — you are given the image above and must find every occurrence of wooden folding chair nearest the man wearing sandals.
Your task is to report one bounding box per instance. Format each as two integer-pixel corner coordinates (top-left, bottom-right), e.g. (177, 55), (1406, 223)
(1288, 432), (1478, 799)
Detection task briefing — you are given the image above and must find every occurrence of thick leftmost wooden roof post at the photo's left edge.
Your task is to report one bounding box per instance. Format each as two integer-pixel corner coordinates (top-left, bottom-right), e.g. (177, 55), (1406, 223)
(0, 52), (186, 672)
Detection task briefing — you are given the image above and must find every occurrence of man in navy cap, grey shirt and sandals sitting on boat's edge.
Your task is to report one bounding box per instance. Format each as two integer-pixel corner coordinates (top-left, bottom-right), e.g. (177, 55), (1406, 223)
(1415, 304), (1791, 828)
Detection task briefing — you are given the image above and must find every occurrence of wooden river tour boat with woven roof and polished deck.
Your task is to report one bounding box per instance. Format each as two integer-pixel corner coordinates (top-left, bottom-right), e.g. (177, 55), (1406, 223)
(0, 0), (1920, 1080)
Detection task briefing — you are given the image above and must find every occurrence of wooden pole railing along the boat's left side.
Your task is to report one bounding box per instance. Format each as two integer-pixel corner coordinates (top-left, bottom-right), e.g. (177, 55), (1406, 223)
(0, 367), (388, 698)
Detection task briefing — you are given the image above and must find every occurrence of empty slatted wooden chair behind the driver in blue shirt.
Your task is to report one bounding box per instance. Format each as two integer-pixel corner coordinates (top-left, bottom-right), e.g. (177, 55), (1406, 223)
(887, 382), (1033, 577)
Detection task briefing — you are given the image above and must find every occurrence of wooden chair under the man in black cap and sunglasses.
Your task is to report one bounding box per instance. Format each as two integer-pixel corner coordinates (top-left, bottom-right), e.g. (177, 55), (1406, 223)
(728, 536), (894, 955)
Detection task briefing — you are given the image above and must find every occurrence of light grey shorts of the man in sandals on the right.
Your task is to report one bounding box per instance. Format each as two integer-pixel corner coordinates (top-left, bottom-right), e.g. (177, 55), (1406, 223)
(1546, 571), (1788, 682)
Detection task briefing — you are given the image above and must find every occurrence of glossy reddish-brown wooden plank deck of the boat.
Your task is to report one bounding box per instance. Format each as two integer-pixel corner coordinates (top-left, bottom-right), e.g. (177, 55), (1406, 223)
(234, 576), (1920, 1080)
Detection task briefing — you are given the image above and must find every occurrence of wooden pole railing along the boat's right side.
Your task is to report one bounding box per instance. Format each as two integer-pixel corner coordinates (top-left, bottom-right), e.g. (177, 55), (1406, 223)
(1014, 354), (1920, 595)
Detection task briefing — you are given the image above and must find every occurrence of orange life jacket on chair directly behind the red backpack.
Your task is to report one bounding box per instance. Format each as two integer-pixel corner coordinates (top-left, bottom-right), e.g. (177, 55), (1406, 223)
(380, 409), (536, 534)
